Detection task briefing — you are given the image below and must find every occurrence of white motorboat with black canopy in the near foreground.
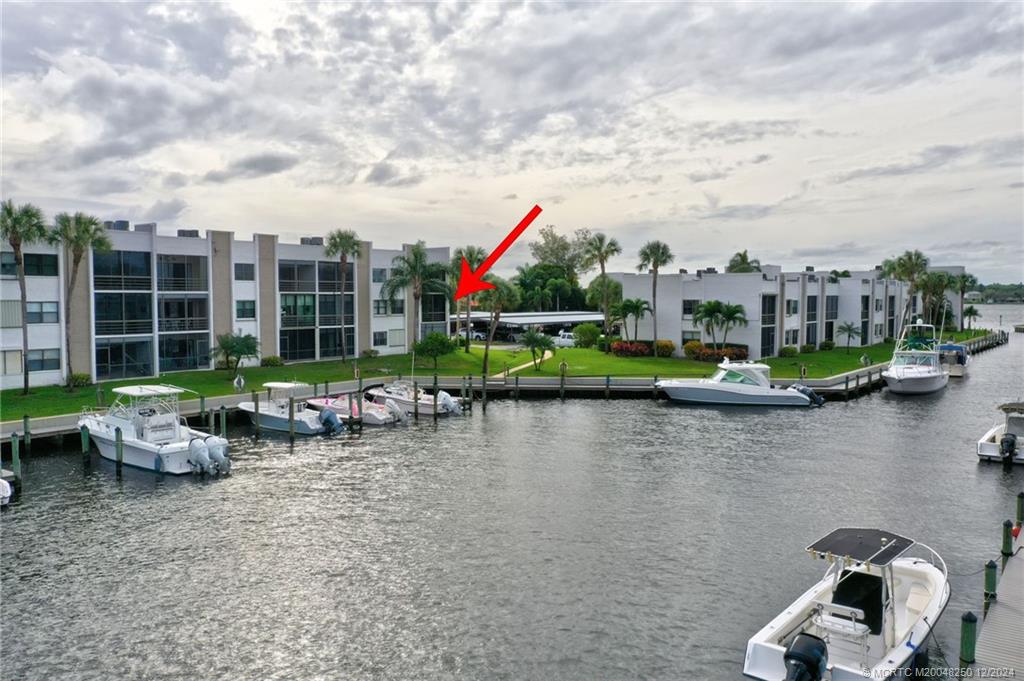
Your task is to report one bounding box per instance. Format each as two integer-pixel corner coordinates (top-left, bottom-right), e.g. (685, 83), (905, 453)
(743, 527), (949, 681)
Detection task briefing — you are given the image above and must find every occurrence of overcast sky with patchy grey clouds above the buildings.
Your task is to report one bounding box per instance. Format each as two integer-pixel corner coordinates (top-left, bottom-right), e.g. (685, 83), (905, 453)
(2, 1), (1024, 282)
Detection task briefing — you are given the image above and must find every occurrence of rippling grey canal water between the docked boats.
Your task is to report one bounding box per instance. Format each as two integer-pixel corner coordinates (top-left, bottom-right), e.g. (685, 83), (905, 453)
(0, 306), (1024, 679)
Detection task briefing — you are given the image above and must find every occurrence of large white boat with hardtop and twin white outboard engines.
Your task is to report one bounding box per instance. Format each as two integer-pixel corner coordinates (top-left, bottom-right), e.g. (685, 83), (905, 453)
(78, 385), (231, 475)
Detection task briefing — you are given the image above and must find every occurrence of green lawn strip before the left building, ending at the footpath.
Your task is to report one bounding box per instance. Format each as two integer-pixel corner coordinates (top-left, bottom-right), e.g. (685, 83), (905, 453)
(0, 346), (529, 421)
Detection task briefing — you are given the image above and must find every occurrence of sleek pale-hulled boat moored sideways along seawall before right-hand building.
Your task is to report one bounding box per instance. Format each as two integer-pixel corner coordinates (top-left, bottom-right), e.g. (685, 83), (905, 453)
(656, 359), (824, 407)
